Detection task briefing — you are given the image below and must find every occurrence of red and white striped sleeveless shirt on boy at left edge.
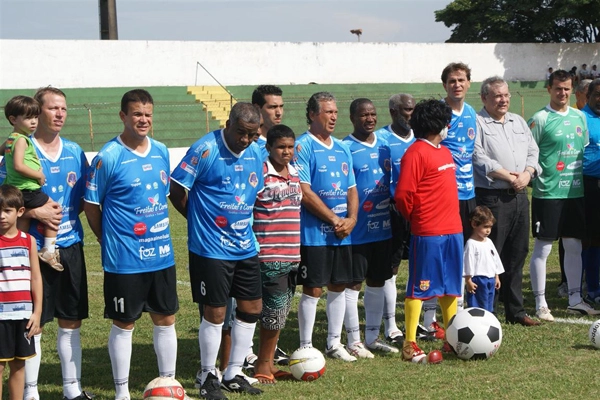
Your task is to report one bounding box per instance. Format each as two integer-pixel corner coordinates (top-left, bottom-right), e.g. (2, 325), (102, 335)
(0, 231), (33, 320)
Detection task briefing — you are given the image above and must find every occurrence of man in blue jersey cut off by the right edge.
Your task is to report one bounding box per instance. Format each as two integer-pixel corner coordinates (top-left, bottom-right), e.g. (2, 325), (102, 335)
(581, 78), (600, 305)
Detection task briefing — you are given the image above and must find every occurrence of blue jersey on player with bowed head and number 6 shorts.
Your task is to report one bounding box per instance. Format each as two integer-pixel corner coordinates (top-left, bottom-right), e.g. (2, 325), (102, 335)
(171, 130), (264, 261)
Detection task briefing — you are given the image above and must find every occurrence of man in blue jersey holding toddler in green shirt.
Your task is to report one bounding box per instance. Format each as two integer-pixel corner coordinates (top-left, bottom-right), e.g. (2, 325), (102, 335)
(17, 87), (91, 400)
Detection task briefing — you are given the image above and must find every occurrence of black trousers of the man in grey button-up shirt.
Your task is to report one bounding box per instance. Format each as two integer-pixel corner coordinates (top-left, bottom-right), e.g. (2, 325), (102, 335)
(476, 188), (529, 322)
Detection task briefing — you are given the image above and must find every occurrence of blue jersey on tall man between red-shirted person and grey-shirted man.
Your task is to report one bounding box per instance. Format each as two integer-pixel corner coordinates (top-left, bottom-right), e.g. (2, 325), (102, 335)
(442, 103), (477, 200)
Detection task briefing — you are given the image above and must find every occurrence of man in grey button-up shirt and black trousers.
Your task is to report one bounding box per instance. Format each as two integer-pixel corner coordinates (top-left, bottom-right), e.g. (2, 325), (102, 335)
(473, 76), (541, 326)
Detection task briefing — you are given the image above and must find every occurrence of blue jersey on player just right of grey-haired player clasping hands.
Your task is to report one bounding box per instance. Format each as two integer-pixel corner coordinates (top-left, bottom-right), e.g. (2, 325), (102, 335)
(343, 135), (392, 244)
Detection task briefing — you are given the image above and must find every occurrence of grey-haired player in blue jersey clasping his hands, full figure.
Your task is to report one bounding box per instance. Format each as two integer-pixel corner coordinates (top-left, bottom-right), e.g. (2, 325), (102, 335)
(295, 92), (358, 361)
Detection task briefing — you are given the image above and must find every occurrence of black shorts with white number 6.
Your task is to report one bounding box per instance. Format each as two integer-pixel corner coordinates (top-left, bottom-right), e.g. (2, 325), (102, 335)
(189, 251), (262, 307)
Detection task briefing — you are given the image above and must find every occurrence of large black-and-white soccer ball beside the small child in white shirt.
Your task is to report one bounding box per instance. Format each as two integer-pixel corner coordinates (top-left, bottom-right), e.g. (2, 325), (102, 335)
(446, 307), (502, 360)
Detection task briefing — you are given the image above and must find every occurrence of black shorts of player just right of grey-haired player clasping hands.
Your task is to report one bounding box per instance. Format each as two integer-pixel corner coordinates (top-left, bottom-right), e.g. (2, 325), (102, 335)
(352, 239), (392, 282)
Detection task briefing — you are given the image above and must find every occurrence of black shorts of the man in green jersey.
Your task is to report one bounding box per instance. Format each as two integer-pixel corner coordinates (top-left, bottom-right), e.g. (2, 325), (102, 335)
(531, 197), (586, 241)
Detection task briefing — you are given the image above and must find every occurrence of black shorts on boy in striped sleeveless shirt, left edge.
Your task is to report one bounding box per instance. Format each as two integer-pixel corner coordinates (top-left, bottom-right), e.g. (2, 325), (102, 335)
(0, 319), (35, 363)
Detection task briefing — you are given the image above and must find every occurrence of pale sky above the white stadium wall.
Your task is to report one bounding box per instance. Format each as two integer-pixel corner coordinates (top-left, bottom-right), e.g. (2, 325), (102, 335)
(0, 0), (451, 43)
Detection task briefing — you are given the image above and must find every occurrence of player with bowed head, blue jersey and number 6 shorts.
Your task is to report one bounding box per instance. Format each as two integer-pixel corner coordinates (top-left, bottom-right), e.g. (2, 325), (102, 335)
(171, 103), (264, 399)
